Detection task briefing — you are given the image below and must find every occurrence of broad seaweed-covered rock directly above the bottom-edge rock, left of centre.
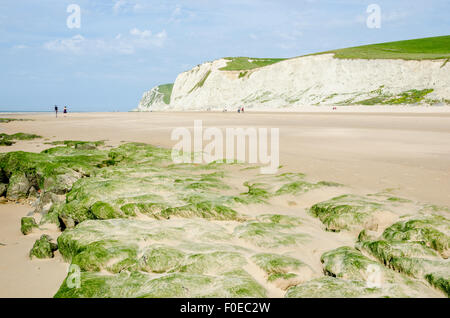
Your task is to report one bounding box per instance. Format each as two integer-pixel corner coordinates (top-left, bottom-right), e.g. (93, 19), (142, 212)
(58, 219), (236, 271)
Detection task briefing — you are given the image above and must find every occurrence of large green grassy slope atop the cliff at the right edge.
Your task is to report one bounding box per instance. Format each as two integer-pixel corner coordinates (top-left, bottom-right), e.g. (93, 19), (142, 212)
(317, 35), (450, 60)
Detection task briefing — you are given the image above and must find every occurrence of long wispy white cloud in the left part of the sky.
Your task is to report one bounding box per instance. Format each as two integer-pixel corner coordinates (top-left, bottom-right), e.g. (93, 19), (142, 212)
(44, 28), (167, 54)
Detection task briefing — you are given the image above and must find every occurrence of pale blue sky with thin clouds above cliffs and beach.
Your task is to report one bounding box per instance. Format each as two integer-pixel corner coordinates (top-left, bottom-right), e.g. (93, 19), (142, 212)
(0, 0), (450, 111)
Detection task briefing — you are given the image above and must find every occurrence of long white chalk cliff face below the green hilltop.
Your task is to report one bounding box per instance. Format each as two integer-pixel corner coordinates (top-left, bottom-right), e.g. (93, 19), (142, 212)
(135, 54), (450, 110)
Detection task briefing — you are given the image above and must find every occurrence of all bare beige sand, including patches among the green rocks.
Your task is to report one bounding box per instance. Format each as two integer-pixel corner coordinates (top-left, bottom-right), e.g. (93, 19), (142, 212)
(0, 109), (450, 297)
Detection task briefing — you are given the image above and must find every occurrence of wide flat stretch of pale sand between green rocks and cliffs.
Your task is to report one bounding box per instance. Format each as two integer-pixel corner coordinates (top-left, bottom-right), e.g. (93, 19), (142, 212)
(0, 108), (450, 205)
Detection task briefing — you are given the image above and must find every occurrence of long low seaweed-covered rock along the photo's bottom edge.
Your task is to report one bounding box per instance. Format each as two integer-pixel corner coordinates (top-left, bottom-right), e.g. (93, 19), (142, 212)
(55, 270), (266, 298)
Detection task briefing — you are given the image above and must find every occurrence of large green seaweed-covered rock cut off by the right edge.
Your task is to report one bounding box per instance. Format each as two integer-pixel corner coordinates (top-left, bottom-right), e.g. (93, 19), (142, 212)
(357, 215), (450, 296)
